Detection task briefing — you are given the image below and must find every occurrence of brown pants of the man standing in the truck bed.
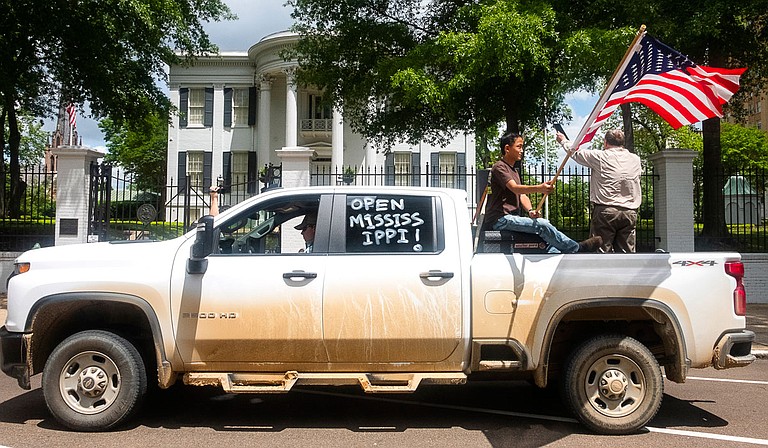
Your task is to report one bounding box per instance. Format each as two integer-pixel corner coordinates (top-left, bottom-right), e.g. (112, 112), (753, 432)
(589, 204), (637, 253)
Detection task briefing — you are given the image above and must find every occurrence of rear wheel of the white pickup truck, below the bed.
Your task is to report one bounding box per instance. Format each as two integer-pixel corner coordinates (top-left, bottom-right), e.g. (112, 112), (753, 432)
(562, 335), (664, 434)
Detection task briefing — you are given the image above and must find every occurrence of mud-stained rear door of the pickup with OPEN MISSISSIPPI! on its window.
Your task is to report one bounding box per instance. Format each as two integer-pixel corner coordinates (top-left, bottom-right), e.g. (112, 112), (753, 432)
(323, 194), (462, 368)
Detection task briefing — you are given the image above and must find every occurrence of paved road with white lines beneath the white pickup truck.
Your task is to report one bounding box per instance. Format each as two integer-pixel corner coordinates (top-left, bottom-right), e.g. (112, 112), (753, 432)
(0, 360), (768, 448)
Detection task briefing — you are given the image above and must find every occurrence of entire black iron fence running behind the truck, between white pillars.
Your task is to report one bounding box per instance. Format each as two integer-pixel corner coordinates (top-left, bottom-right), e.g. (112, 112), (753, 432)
(0, 165), (768, 253)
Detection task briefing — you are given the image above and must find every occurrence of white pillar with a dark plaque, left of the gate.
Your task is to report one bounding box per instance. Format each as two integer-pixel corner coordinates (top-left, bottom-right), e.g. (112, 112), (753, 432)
(53, 146), (104, 246)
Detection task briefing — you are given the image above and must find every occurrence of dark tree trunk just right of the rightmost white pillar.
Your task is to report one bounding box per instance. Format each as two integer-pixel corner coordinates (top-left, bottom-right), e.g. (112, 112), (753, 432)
(701, 117), (728, 242)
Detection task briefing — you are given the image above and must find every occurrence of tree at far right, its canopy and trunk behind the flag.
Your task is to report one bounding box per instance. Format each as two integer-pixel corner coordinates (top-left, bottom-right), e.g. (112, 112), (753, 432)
(553, 0), (768, 245)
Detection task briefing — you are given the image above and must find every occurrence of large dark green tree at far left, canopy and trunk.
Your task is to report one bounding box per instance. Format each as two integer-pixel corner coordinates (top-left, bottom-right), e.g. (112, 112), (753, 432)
(0, 0), (234, 214)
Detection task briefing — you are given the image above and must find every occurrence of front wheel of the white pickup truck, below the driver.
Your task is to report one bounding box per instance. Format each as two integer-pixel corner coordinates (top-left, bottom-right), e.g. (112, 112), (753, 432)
(42, 330), (147, 431)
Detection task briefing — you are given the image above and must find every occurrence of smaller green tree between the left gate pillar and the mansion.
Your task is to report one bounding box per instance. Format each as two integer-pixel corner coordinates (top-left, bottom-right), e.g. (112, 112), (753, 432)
(99, 113), (168, 191)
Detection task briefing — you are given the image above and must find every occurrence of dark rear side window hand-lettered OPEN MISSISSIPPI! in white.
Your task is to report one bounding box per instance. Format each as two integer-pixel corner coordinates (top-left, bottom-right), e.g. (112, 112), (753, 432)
(346, 195), (434, 252)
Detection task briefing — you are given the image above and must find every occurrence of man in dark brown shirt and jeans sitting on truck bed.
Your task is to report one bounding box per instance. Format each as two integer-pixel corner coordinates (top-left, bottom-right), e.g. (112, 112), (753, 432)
(485, 132), (602, 254)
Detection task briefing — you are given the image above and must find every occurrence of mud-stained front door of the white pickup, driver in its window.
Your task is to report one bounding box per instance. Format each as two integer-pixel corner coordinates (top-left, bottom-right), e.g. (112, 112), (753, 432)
(172, 195), (331, 371)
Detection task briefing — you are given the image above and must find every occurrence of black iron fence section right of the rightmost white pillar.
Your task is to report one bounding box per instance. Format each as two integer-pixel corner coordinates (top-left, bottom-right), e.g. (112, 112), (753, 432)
(693, 167), (768, 253)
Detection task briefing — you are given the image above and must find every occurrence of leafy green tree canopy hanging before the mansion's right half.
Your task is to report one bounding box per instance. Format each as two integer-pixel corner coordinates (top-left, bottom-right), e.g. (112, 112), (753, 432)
(288, 0), (634, 147)
